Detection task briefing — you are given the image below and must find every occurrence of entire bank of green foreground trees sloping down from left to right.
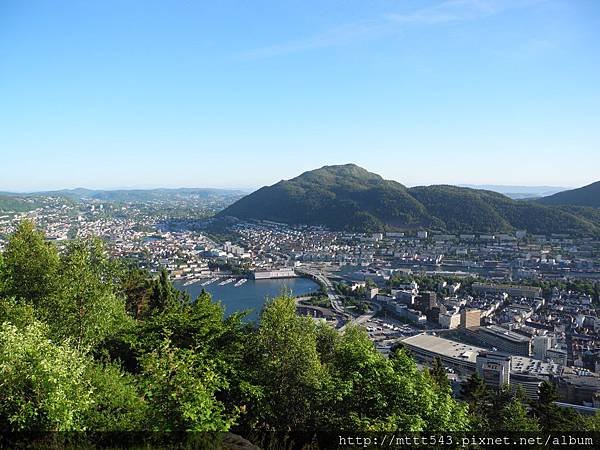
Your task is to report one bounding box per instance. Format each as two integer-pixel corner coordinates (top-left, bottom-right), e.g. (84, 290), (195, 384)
(0, 223), (600, 436)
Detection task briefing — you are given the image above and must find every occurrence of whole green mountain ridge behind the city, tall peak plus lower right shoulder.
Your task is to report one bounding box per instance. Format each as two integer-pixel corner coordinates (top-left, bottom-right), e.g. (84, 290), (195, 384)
(219, 164), (600, 236)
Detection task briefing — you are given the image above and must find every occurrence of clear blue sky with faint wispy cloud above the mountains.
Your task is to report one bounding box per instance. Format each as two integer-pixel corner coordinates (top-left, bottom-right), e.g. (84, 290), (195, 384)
(0, 0), (600, 191)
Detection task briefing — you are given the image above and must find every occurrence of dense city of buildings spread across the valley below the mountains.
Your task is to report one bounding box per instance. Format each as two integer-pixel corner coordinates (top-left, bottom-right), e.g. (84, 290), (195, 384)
(0, 192), (600, 414)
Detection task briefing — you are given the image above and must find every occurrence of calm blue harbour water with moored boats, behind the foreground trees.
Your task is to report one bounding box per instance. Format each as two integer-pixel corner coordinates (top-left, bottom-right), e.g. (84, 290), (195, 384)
(175, 278), (319, 320)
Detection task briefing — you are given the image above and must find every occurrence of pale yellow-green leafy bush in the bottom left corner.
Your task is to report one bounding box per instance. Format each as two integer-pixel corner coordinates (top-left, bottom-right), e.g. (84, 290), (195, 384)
(0, 321), (93, 431)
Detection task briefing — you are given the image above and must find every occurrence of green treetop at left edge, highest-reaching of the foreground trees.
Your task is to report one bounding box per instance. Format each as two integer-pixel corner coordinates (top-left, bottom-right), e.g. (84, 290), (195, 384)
(0, 220), (59, 305)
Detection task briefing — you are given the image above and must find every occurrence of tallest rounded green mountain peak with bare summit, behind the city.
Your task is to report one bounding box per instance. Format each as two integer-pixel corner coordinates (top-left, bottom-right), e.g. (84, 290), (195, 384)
(220, 164), (432, 231)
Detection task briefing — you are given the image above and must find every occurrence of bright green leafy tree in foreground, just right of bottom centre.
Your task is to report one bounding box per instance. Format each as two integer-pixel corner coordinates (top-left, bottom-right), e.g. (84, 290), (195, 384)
(322, 326), (469, 432)
